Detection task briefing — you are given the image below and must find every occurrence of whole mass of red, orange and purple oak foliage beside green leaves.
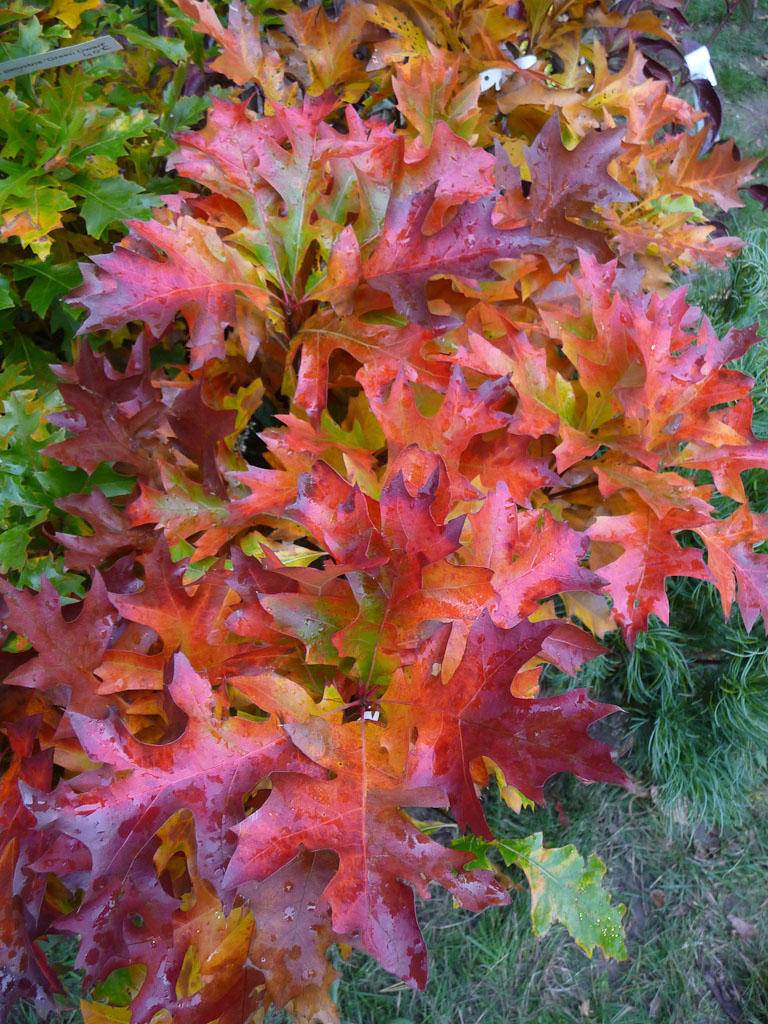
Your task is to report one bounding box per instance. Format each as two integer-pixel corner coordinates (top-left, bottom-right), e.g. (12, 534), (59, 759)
(0, 0), (768, 1024)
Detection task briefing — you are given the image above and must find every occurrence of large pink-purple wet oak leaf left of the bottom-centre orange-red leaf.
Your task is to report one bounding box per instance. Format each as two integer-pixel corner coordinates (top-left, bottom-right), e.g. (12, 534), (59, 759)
(35, 654), (316, 899)
